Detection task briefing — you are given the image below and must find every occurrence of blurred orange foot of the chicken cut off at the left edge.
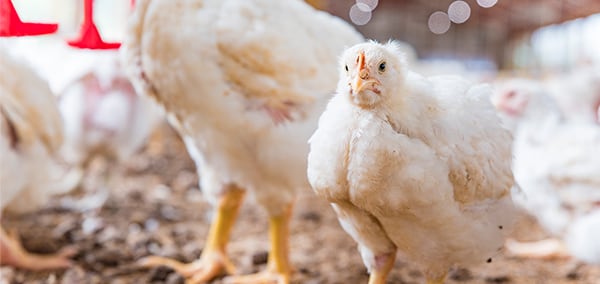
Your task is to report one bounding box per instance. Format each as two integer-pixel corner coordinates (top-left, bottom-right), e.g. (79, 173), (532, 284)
(0, 228), (77, 271)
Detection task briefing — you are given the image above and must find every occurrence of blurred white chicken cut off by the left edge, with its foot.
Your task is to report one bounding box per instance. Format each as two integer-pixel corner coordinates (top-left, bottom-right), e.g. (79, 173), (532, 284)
(0, 49), (81, 270)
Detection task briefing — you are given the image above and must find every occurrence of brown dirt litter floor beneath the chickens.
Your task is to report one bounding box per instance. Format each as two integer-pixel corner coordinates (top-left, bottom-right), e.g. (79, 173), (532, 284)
(0, 127), (600, 283)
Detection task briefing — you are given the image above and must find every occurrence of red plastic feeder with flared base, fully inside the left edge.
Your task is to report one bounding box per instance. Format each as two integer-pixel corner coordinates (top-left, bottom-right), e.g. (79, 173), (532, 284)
(68, 0), (121, 49)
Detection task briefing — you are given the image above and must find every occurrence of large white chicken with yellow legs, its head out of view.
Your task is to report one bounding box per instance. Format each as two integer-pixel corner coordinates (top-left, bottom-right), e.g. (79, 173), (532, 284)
(124, 0), (362, 283)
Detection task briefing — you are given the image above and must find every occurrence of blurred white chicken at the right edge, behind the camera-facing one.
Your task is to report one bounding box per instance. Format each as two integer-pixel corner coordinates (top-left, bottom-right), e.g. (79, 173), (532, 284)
(494, 79), (600, 263)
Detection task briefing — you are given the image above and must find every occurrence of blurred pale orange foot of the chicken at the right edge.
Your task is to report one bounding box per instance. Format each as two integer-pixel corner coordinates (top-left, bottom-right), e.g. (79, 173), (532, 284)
(504, 239), (570, 259)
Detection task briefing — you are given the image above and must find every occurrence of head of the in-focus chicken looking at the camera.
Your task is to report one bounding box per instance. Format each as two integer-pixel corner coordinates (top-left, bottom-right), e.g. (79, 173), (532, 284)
(337, 41), (406, 108)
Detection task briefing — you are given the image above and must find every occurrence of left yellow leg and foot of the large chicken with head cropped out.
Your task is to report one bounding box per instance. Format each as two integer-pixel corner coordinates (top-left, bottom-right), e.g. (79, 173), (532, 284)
(138, 188), (245, 283)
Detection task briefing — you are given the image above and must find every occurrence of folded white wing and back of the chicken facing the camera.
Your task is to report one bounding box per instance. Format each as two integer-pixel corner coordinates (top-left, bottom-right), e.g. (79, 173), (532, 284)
(397, 74), (514, 205)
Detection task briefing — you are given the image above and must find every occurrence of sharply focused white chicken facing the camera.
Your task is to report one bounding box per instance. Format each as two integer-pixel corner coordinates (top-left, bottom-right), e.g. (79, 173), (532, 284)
(308, 42), (514, 283)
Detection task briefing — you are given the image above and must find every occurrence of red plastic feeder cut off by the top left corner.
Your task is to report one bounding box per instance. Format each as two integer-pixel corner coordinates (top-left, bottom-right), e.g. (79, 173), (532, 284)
(0, 0), (58, 37)
